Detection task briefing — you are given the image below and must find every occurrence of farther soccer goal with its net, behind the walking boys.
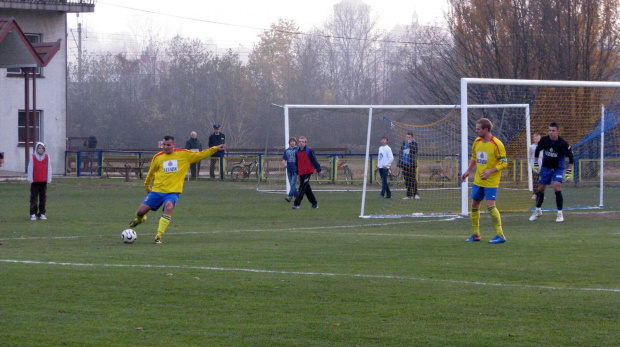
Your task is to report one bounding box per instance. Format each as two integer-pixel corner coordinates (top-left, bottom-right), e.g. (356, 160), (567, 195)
(259, 104), (531, 218)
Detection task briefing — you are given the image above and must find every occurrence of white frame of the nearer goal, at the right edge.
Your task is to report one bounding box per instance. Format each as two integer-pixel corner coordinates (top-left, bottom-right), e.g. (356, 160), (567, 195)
(461, 77), (620, 216)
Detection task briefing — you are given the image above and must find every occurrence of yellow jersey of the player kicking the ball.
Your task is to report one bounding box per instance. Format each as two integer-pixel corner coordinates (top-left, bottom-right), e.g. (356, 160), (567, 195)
(144, 146), (217, 193)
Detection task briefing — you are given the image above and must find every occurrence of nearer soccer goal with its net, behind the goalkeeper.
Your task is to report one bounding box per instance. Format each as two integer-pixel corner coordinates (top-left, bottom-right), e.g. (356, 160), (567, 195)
(460, 78), (620, 215)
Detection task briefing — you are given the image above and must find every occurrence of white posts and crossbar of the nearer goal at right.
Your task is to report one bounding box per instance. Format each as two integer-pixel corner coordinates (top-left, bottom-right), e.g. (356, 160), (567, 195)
(460, 78), (620, 215)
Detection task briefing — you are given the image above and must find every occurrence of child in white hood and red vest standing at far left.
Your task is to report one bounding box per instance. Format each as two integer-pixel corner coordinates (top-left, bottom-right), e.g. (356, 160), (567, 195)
(28, 142), (52, 220)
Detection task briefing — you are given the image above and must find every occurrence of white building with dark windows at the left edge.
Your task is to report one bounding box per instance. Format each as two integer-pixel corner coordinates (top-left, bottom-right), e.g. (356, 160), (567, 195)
(0, 0), (95, 174)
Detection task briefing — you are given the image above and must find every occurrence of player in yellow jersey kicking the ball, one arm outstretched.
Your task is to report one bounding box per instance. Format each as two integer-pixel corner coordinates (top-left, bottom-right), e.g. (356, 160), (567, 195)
(129, 135), (226, 243)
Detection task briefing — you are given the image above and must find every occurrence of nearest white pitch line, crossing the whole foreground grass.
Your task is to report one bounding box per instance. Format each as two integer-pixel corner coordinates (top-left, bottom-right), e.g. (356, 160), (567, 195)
(0, 259), (620, 293)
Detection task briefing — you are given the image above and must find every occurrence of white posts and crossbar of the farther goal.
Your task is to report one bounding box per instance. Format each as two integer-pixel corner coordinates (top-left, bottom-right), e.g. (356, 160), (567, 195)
(282, 104), (532, 218)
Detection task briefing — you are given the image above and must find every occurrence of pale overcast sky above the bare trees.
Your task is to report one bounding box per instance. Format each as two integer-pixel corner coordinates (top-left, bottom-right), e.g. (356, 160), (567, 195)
(68, 0), (447, 55)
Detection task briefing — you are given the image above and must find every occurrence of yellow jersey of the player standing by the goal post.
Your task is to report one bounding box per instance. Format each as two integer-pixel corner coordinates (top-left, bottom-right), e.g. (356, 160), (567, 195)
(471, 136), (508, 188)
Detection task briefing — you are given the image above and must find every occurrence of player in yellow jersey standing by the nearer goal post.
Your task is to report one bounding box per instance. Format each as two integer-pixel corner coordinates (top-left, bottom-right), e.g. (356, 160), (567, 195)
(461, 118), (508, 243)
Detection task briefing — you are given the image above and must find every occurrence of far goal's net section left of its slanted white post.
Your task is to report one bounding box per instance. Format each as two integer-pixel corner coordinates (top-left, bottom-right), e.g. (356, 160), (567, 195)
(258, 105), (368, 194)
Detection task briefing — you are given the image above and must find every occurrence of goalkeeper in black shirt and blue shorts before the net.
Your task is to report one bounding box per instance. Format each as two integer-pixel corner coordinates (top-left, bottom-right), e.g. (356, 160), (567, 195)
(530, 122), (575, 223)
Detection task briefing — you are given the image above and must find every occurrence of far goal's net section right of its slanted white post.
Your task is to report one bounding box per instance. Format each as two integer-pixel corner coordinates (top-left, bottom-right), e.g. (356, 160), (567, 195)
(361, 104), (528, 218)
